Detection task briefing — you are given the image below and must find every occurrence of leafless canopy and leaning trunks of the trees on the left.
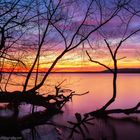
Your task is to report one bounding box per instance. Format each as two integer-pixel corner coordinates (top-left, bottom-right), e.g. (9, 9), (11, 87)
(0, 0), (129, 92)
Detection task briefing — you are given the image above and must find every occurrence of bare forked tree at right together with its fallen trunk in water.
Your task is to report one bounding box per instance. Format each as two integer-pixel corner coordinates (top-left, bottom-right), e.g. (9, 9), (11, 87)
(69, 1), (140, 137)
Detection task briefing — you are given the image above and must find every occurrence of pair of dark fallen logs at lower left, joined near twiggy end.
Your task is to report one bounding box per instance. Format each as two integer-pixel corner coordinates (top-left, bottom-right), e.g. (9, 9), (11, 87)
(0, 88), (88, 134)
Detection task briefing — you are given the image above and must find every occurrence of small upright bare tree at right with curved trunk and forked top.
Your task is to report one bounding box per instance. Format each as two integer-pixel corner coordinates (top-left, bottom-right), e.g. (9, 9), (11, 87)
(86, 0), (140, 114)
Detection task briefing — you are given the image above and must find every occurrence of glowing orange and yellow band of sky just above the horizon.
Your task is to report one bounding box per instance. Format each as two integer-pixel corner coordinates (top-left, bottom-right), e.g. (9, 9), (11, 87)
(1, 47), (140, 72)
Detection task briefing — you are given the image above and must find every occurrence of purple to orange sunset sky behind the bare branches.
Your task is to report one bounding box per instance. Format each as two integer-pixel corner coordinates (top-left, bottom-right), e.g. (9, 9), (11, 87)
(1, 0), (140, 72)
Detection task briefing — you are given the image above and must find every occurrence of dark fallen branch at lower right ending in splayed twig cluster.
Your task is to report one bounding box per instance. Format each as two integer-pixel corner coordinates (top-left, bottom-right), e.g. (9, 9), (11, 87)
(68, 102), (140, 138)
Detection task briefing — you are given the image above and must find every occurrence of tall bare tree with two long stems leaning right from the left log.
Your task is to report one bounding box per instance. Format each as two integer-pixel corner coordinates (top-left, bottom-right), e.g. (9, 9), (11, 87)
(23, 0), (130, 92)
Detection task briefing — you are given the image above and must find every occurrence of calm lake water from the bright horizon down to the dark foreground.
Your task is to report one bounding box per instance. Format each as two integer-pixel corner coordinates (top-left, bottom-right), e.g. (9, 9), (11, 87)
(0, 74), (140, 140)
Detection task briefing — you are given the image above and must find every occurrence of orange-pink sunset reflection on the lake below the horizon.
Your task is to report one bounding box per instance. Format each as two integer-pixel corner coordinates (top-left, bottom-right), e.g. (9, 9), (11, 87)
(3, 73), (140, 113)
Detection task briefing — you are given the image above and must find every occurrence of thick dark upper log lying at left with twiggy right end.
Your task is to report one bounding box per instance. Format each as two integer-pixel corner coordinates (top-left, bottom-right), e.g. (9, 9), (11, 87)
(0, 89), (88, 110)
